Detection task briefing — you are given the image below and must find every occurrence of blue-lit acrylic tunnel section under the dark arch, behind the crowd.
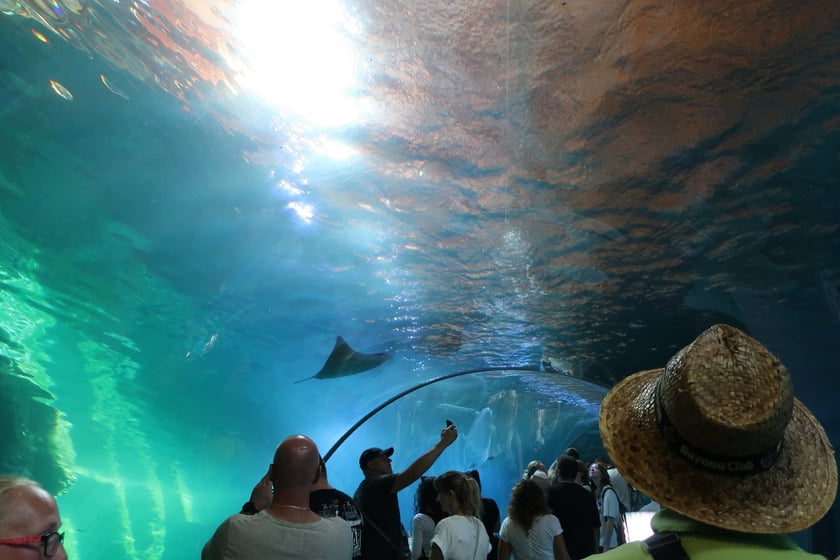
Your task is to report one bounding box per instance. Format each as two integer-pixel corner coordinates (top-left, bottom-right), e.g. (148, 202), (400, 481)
(322, 370), (607, 528)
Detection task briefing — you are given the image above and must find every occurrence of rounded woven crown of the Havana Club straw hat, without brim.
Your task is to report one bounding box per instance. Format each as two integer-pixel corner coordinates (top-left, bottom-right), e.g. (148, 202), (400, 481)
(657, 325), (794, 457)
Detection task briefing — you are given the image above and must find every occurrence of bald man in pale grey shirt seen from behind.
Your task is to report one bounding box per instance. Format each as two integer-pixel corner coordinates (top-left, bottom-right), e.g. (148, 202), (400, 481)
(201, 435), (353, 560)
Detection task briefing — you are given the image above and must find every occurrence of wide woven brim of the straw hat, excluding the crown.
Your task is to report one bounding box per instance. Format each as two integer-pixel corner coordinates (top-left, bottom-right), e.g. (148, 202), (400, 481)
(599, 368), (837, 534)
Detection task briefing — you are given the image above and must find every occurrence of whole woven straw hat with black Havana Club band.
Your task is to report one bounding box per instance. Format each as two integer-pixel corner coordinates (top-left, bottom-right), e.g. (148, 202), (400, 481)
(599, 325), (837, 534)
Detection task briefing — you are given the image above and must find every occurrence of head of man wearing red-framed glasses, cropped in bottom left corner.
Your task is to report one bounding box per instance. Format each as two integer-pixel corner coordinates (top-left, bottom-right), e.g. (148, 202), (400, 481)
(0, 476), (67, 560)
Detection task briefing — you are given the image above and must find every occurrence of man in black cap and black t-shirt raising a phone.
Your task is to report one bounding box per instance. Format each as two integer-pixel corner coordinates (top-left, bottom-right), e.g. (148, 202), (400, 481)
(354, 425), (458, 560)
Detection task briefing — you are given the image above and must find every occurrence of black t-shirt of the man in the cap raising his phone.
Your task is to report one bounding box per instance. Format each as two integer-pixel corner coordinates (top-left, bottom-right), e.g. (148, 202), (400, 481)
(354, 474), (405, 560)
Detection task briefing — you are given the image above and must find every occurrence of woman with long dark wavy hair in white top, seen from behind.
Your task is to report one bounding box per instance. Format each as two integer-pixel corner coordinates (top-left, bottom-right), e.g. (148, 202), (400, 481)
(499, 480), (571, 560)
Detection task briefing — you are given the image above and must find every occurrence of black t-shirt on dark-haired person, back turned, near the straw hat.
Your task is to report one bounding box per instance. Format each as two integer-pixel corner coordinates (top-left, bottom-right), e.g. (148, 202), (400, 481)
(548, 482), (601, 560)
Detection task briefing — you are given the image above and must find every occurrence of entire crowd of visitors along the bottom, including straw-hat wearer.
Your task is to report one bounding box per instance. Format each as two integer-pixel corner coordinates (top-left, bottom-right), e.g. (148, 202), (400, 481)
(0, 325), (837, 560)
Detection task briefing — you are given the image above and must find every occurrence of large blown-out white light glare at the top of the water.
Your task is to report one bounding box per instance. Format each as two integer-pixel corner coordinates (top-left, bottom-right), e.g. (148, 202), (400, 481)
(231, 0), (358, 127)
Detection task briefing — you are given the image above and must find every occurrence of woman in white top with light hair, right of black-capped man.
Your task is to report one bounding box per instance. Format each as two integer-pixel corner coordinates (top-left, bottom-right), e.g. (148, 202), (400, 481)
(429, 471), (490, 560)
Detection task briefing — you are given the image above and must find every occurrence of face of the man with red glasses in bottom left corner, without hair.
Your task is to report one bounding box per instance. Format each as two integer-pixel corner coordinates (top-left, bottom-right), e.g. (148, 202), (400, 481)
(0, 486), (67, 560)
